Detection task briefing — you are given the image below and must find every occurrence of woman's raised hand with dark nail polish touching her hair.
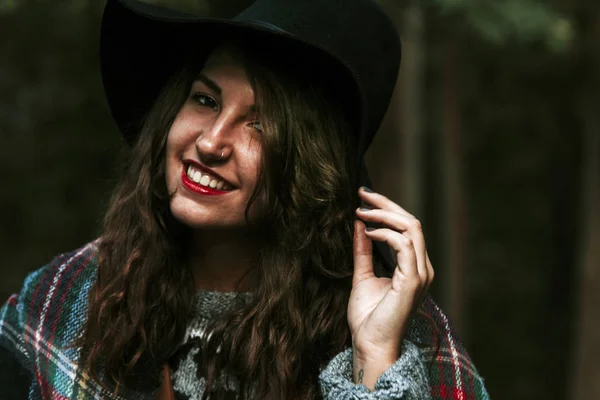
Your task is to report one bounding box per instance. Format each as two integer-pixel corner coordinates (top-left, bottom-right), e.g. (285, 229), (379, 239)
(348, 187), (434, 388)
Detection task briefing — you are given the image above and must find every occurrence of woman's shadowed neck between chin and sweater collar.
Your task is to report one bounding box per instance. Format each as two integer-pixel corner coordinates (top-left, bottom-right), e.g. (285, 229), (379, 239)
(187, 231), (258, 292)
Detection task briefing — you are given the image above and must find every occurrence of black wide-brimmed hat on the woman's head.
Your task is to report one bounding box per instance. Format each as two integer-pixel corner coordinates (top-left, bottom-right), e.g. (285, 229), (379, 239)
(100, 0), (400, 155)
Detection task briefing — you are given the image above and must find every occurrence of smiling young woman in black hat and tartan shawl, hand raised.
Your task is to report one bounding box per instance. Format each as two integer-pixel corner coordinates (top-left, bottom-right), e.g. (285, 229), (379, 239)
(0, 0), (487, 399)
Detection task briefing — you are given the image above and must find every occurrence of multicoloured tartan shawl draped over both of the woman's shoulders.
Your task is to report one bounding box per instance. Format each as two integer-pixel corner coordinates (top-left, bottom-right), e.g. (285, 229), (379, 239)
(0, 241), (489, 400)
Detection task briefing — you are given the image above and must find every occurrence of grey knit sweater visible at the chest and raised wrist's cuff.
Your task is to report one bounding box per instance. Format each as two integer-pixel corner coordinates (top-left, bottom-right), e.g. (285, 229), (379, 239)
(171, 290), (431, 400)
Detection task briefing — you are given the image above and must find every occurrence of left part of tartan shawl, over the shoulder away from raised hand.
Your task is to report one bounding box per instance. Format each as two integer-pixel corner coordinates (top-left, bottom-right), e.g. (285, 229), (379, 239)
(0, 242), (141, 400)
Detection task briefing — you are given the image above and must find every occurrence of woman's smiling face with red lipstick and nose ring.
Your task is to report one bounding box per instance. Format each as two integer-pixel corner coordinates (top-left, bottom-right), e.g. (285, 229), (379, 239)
(165, 49), (262, 229)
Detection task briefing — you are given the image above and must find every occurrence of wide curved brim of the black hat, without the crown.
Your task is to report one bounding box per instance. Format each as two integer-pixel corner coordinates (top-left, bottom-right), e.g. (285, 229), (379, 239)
(100, 0), (364, 143)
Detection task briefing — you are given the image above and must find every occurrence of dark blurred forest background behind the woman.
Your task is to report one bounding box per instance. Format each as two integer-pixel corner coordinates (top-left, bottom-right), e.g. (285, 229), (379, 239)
(0, 0), (600, 400)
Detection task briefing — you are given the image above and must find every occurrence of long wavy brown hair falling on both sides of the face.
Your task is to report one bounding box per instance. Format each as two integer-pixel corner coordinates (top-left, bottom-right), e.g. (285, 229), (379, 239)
(78, 36), (370, 399)
